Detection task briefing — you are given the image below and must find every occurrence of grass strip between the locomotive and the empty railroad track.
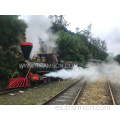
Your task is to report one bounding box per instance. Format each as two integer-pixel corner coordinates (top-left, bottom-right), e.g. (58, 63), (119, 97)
(0, 80), (75, 105)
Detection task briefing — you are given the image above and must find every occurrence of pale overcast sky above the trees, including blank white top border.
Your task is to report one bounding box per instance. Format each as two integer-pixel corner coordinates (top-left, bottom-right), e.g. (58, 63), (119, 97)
(0, 0), (120, 55)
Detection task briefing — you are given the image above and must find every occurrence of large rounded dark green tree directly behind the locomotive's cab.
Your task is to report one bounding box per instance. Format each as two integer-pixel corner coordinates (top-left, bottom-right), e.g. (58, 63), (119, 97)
(57, 31), (89, 65)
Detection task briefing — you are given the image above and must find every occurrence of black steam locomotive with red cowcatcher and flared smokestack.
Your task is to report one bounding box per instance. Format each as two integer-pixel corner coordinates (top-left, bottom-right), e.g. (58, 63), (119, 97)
(7, 42), (73, 89)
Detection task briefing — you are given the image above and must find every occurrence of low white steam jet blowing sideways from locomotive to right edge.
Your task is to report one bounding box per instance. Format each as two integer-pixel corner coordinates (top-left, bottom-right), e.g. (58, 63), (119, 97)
(45, 61), (120, 82)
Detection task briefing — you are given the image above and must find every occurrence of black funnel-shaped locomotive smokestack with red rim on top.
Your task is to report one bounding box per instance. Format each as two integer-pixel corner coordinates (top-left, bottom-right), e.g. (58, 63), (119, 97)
(20, 42), (33, 60)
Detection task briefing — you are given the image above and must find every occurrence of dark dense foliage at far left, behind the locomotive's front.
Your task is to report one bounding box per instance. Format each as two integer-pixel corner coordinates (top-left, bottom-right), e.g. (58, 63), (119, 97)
(0, 15), (27, 80)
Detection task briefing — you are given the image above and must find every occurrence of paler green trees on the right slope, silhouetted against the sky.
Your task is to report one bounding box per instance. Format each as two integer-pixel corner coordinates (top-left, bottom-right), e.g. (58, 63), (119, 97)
(77, 24), (108, 60)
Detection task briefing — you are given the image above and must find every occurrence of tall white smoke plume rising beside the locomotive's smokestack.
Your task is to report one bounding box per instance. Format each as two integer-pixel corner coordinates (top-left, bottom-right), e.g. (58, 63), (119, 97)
(22, 15), (57, 58)
